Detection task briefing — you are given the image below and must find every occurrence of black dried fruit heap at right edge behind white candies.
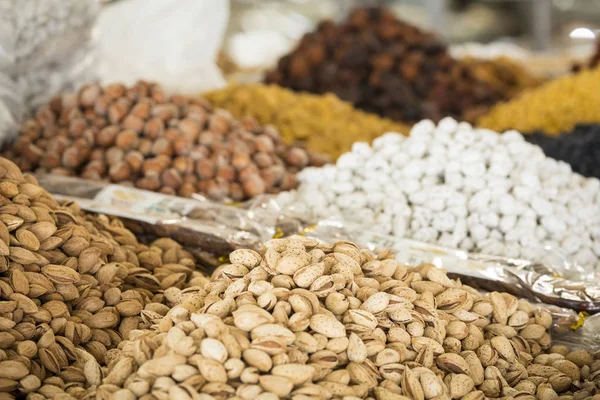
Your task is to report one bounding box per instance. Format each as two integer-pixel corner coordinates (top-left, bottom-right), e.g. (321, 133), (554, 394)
(525, 124), (600, 178)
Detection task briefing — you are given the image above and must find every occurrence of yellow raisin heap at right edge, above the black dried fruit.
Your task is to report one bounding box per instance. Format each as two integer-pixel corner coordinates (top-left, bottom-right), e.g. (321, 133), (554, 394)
(478, 68), (600, 135)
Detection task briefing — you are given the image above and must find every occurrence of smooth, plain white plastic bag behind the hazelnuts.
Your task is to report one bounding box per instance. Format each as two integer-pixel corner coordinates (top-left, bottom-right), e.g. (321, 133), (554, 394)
(97, 0), (229, 93)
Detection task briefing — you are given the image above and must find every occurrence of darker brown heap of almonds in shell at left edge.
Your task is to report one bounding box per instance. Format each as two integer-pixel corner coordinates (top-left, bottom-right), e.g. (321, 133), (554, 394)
(0, 158), (206, 400)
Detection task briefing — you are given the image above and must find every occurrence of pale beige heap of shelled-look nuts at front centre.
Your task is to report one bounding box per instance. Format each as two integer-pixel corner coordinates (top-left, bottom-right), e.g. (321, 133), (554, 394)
(87, 237), (600, 400)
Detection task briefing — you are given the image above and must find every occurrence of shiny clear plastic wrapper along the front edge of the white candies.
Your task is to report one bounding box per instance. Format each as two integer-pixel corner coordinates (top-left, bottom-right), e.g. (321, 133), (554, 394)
(305, 220), (600, 313)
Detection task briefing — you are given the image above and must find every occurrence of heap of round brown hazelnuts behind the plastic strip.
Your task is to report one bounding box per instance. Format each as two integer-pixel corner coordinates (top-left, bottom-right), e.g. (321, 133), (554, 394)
(7, 82), (324, 200)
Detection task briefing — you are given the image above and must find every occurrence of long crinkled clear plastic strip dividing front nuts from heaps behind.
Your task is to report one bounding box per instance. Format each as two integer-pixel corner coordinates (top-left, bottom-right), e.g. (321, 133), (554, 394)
(38, 183), (600, 350)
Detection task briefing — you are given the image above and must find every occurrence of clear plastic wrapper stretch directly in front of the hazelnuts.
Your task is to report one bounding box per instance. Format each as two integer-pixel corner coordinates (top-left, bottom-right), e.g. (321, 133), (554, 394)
(37, 175), (275, 267)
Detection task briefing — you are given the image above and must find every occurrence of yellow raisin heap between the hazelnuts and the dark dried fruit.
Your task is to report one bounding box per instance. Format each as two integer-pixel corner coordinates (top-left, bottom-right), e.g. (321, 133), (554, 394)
(203, 84), (410, 159)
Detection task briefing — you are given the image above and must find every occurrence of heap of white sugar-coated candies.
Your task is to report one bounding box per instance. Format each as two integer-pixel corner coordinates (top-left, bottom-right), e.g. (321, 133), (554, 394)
(278, 118), (600, 270)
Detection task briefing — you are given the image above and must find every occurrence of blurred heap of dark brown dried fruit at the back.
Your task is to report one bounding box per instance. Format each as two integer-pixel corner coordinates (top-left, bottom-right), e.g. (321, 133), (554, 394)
(266, 8), (505, 122)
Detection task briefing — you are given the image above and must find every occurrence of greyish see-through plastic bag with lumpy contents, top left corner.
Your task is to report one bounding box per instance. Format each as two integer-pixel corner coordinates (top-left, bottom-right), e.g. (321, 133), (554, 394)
(0, 0), (100, 144)
